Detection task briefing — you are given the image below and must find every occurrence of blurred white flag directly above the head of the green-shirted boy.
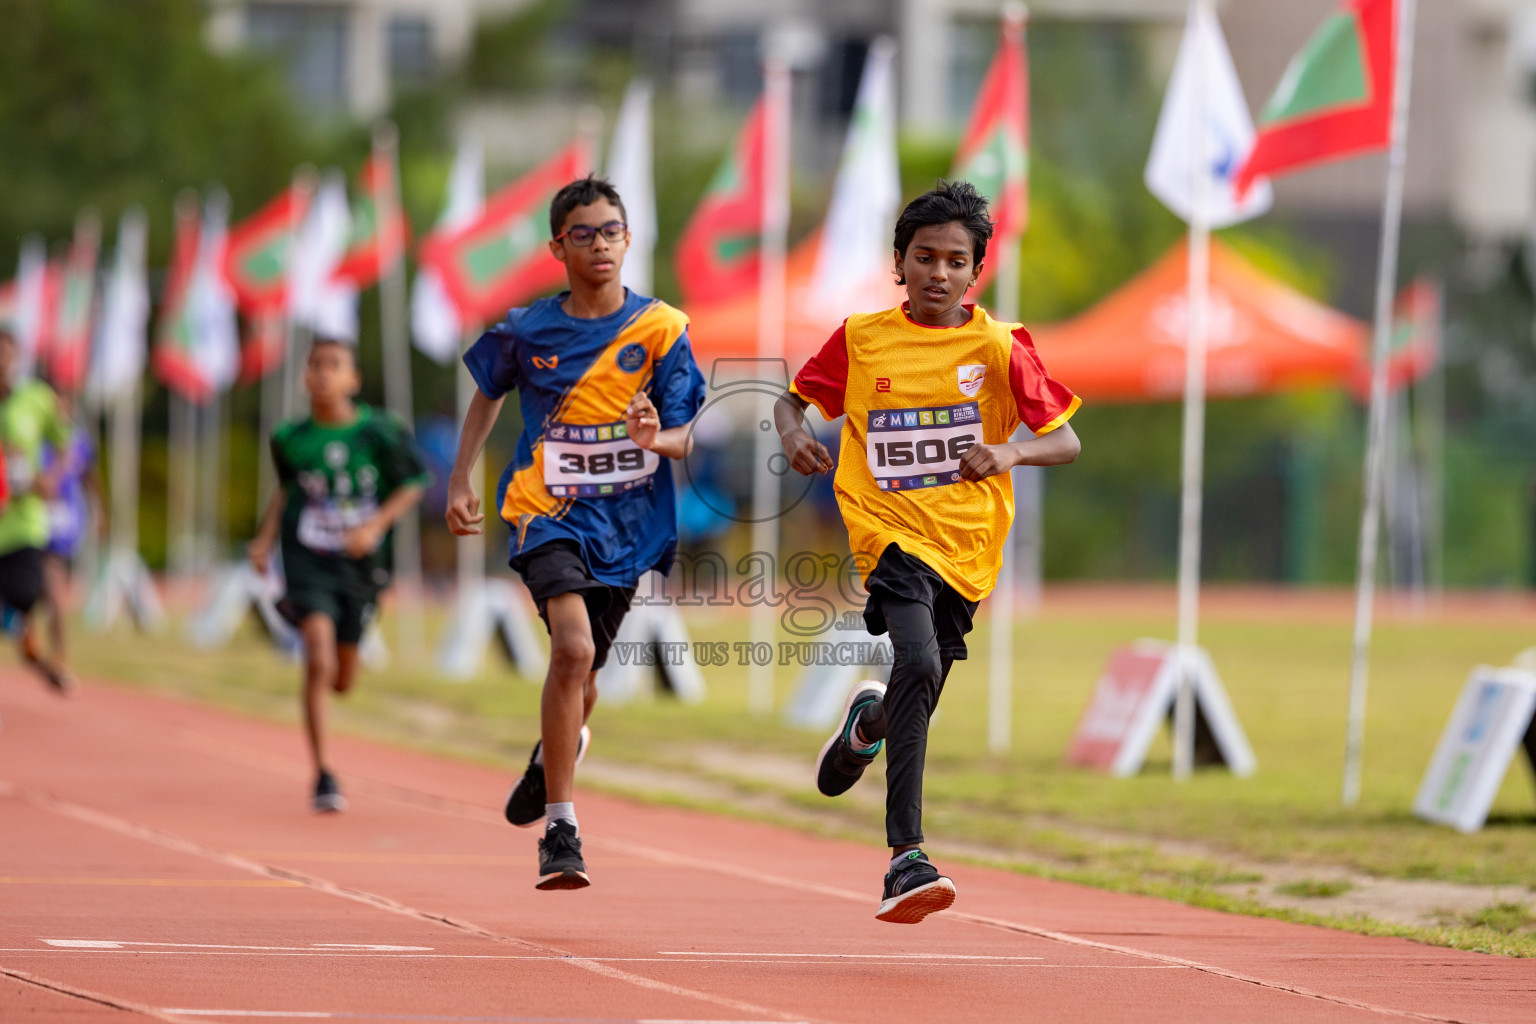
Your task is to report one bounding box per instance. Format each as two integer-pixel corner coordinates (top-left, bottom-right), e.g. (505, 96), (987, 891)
(289, 169), (358, 341)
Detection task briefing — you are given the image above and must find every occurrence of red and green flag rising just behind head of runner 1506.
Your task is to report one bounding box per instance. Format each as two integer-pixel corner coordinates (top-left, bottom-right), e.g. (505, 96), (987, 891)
(949, 15), (1029, 289)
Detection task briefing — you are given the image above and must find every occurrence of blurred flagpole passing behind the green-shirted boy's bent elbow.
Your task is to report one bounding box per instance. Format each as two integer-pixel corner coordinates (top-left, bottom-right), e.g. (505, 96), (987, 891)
(372, 121), (427, 663)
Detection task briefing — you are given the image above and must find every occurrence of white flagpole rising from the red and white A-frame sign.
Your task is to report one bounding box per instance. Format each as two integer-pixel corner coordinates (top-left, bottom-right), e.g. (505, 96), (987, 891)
(1174, 0), (1215, 781)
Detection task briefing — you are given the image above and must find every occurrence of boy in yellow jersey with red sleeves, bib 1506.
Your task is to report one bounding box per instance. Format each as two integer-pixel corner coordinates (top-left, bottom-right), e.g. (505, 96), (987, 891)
(774, 181), (1080, 924)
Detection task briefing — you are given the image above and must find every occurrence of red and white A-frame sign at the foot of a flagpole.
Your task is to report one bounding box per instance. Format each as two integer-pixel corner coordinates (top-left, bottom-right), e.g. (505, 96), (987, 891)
(1066, 640), (1258, 777)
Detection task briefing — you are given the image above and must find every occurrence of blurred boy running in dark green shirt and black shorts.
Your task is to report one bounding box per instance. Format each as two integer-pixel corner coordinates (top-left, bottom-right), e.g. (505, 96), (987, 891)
(249, 338), (430, 811)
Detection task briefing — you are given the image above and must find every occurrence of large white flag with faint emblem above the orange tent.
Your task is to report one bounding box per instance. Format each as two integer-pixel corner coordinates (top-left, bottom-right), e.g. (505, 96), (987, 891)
(1146, 3), (1275, 229)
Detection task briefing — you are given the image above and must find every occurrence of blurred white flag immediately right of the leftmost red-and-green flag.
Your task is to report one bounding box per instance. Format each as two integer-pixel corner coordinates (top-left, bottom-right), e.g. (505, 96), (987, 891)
(86, 206), (149, 405)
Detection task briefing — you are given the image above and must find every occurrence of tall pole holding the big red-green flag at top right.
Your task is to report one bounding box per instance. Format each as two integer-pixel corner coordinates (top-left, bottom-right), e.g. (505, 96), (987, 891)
(1344, 0), (1418, 808)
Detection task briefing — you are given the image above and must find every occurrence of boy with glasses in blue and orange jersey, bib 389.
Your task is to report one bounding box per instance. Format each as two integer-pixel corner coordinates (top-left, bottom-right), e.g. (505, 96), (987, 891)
(447, 177), (703, 889)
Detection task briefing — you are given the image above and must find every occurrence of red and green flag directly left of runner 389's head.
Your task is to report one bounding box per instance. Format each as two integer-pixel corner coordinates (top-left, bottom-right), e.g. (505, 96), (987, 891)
(421, 138), (591, 322)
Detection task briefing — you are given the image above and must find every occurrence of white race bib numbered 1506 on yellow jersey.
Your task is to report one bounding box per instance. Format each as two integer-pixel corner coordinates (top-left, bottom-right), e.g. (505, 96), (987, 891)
(865, 402), (982, 491)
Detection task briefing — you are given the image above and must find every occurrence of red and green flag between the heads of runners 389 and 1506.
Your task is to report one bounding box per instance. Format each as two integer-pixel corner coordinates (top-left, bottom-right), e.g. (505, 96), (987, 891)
(673, 97), (768, 306)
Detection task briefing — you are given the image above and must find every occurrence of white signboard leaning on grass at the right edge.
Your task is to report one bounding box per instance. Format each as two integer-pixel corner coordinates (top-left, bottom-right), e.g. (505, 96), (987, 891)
(1413, 665), (1536, 832)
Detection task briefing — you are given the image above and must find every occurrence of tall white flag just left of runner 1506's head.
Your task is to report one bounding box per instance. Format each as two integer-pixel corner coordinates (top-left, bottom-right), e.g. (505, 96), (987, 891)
(816, 37), (902, 313)
